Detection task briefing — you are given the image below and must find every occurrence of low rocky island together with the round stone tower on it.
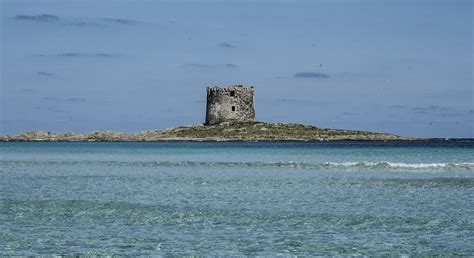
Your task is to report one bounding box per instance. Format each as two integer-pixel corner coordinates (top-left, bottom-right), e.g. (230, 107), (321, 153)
(0, 85), (408, 142)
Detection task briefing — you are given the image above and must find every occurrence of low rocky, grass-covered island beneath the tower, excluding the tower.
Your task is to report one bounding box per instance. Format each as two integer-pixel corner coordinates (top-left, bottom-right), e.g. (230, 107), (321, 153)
(0, 122), (408, 142)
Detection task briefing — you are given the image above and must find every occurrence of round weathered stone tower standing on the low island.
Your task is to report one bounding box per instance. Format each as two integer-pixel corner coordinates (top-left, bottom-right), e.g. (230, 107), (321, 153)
(206, 85), (255, 125)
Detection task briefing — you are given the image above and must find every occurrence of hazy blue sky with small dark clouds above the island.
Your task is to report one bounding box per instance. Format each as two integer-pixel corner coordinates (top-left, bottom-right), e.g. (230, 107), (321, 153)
(0, 0), (474, 138)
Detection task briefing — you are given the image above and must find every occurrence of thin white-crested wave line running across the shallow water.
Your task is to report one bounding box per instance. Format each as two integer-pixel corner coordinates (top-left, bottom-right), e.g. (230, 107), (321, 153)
(0, 160), (474, 171)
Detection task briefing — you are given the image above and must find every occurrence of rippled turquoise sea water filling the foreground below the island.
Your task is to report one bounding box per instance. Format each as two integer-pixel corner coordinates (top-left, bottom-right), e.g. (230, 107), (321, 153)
(0, 142), (474, 256)
